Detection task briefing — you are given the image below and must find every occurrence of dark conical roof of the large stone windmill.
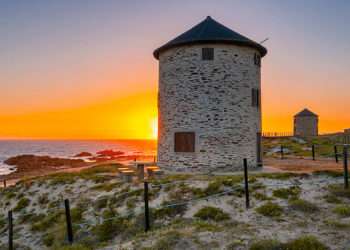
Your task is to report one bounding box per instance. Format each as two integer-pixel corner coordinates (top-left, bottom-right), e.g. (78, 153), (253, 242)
(153, 16), (267, 59)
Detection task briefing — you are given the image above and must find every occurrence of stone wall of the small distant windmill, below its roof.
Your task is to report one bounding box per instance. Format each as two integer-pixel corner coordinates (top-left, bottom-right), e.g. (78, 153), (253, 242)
(294, 116), (318, 137)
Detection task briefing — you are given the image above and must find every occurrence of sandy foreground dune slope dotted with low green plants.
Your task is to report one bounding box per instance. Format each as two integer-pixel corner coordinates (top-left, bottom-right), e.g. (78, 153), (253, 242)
(0, 165), (350, 250)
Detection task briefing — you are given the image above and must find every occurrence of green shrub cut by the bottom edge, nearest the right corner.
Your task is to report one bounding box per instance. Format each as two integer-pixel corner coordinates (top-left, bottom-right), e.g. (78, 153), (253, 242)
(284, 236), (328, 250)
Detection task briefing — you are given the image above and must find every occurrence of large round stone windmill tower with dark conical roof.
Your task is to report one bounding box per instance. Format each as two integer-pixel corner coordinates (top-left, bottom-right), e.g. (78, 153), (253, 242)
(153, 17), (267, 171)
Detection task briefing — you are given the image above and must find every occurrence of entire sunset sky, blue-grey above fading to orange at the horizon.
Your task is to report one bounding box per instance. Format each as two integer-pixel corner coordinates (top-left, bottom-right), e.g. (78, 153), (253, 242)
(0, 0), (350, 139)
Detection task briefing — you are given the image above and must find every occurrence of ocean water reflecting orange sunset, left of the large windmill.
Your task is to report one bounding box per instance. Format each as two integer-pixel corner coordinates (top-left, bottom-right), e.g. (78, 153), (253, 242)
(0, 140), (157, 175)
